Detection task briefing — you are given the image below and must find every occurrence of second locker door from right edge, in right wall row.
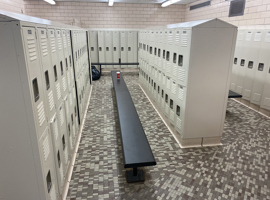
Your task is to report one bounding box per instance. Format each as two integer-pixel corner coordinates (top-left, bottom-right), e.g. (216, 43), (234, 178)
(251, 30), (270, 105)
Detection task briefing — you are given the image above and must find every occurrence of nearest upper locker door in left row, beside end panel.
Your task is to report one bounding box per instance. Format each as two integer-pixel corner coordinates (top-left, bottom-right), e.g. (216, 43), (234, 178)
(22, 27), (48, 138)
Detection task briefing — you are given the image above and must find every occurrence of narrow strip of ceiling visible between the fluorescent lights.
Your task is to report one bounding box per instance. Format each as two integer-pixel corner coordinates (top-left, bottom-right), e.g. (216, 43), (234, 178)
(56, 0), (198, 4)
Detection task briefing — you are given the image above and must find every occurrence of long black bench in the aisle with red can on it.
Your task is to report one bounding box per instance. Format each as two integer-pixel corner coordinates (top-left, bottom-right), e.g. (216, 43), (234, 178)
(111, 71), (156, 183)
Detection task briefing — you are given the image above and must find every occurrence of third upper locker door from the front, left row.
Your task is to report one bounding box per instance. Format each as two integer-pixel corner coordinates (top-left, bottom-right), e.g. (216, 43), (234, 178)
(48, 29), (62, 107)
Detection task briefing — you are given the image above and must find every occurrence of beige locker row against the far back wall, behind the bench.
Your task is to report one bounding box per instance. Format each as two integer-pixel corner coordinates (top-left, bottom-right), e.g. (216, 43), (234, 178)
(89, 29), (138, 68)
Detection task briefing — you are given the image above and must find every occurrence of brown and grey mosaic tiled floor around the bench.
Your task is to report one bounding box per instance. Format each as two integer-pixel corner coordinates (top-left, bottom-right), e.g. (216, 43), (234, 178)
(67, 76), (270, 200)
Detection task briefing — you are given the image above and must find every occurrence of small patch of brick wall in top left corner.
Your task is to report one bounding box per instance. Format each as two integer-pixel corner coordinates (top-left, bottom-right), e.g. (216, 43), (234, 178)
(0, 0), (24, 13)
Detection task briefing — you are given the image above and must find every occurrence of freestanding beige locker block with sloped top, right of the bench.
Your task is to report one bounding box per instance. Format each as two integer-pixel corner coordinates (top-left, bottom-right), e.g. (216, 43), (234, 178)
(139, 19), (237, 146)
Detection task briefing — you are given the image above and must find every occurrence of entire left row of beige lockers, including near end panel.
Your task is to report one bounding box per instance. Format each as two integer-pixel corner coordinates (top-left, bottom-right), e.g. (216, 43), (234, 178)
(0, 11), (91, 200)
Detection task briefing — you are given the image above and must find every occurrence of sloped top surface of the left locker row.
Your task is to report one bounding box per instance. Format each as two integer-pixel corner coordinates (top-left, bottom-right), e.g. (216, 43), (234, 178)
(0, 10), (85, 30)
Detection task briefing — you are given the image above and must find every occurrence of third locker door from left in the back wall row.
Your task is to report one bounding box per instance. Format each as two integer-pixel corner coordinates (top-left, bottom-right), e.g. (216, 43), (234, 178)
(105, 31), (113, 68)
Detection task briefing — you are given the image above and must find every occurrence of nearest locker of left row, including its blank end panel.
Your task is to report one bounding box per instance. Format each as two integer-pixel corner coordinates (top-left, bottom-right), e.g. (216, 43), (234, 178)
(0, 18), (58, 200)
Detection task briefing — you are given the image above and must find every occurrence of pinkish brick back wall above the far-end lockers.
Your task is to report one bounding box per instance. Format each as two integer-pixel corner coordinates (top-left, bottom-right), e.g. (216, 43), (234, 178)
(25, 1), (185, 28)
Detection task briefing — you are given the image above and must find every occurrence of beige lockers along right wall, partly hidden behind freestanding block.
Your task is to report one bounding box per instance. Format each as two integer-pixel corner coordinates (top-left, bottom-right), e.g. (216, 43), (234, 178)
(231, 26), (270, 110)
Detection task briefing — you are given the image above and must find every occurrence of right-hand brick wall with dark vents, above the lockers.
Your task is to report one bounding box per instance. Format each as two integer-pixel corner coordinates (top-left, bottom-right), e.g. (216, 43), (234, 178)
(185, 0), (270, 26)
